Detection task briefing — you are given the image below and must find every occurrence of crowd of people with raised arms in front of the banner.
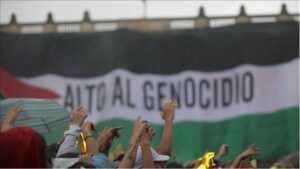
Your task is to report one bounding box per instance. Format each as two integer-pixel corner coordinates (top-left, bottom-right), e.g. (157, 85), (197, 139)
(0, 101), (297, 169)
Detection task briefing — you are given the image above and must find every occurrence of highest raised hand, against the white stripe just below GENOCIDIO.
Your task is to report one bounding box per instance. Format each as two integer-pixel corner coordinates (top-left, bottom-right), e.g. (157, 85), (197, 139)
(160, 100), (177, 121)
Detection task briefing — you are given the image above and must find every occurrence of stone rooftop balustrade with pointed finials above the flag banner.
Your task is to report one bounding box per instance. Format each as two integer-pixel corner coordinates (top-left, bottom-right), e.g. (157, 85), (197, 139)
(0, 4), (299, 34)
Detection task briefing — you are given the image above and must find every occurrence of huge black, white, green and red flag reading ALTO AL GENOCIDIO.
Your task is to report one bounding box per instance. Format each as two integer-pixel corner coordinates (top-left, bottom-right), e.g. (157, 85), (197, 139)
(0, 22), (299, 162)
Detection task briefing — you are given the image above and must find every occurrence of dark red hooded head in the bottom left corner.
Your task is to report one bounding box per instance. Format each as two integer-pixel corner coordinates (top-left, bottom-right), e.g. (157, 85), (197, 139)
(0, 127), (52, 168)
